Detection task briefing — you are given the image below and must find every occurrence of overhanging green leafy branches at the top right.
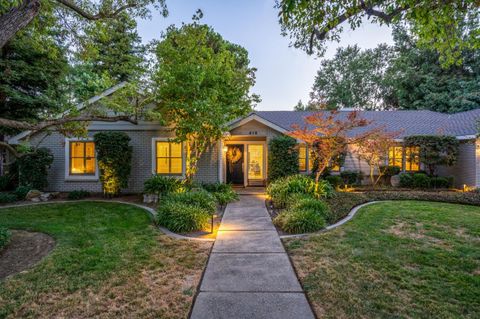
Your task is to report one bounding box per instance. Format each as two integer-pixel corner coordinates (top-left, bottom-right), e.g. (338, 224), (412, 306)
(275, 0), (480, 66)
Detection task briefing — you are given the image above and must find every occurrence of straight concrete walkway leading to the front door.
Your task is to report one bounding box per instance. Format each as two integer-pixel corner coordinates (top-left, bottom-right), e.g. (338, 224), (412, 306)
(191, 195), (314, 319)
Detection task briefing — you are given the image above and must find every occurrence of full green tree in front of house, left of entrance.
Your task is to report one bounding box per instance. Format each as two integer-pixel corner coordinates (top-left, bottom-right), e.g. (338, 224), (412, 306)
(151, 21), (259, 181)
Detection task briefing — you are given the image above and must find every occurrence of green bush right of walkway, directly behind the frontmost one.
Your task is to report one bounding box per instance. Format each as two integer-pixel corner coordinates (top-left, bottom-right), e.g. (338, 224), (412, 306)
(267, 175), (334, 208)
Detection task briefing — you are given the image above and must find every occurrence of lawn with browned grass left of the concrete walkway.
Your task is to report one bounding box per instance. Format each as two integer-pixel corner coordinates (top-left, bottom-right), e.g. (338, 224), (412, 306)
(0, 202), (210, 318)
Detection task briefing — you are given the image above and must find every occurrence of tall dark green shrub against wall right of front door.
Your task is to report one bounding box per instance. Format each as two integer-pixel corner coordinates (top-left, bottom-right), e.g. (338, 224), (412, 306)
(268, 135), (298, 182)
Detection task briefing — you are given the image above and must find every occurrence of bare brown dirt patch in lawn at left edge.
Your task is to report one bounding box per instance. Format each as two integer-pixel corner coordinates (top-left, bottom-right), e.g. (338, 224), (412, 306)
(0, 230), (55, 280)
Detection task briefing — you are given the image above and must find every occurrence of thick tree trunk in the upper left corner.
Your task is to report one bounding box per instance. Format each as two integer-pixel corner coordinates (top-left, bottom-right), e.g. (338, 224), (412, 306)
(0, 0), (40, 49)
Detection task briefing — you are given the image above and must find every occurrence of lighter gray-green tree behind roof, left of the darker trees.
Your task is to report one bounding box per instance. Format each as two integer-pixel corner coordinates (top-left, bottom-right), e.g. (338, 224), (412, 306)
(310, 44), (394, 110)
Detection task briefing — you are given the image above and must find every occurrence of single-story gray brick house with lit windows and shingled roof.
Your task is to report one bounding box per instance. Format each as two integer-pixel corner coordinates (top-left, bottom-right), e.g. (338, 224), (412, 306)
(9, 84), (480, 193)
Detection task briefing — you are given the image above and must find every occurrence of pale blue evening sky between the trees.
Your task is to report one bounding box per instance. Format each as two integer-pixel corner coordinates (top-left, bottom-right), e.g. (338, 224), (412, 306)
(138, 0), (392, 111)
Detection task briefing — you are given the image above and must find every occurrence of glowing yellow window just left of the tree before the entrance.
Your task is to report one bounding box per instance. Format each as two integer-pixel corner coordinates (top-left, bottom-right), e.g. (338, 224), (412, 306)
(156, 141), (183, 175)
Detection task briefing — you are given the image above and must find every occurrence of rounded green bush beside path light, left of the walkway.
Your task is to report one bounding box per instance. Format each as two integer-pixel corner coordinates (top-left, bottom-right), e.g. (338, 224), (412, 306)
(157, 200), (211, 233)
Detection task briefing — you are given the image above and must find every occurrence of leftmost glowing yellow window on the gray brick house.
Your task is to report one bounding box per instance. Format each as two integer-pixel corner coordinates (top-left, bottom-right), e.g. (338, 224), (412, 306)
(70, 141), (96, 175)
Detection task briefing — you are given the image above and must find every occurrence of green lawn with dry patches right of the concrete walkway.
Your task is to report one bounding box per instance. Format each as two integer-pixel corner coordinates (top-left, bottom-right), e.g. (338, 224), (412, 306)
(286, 201), (480, 318)
